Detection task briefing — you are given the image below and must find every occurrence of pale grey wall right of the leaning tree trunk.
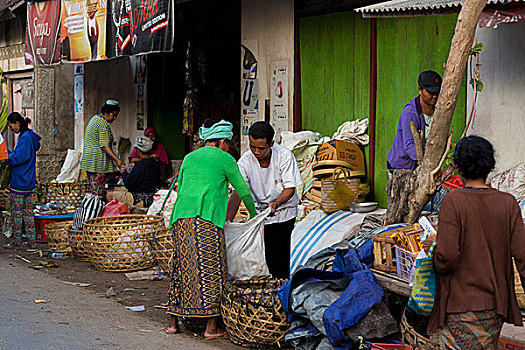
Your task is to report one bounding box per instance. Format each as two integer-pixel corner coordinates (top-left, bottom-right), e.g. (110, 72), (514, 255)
(467, 21), (525, 173)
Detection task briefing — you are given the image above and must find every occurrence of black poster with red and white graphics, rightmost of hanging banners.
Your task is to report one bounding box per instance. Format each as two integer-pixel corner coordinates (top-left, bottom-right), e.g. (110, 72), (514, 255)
(107, 0), (174, 57)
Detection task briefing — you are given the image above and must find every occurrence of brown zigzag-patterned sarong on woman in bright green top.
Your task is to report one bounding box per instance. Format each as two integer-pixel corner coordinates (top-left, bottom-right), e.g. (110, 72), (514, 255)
(168, 218), (226, 317)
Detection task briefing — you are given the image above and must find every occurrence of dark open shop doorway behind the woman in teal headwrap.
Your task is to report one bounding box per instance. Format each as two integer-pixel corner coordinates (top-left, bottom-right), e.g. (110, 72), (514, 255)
(147, 0), (241, 159)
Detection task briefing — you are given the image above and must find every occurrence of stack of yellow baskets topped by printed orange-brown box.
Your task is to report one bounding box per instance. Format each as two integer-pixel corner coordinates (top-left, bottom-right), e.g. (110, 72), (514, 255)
(305, 140), (370, 205)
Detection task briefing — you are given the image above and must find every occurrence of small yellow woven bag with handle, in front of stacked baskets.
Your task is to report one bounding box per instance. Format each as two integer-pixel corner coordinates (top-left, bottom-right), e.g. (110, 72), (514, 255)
(321, 167), (360, 214)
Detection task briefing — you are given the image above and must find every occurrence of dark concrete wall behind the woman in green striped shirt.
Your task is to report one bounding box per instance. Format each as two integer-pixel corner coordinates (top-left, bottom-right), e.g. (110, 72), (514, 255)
(84, 57), (147, 159)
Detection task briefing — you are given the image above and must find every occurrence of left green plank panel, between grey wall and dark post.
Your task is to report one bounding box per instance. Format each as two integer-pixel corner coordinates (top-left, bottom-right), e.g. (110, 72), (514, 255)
(300, 12), (370, 136)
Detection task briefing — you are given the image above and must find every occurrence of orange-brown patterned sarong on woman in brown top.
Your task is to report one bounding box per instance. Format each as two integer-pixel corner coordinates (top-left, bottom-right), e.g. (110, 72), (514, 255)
(440, 310), (503, 350)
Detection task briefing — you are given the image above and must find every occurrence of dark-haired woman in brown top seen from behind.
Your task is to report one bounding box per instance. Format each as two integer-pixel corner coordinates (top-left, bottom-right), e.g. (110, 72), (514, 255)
(429, 136), (525, 350)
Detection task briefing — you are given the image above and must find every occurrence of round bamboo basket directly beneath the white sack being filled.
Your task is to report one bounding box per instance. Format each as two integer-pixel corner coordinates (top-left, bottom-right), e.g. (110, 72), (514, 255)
(221, 279), (290, 348)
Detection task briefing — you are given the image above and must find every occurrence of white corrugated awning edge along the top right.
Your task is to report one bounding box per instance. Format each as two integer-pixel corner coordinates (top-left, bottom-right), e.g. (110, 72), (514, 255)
(355, 0), (523, 18)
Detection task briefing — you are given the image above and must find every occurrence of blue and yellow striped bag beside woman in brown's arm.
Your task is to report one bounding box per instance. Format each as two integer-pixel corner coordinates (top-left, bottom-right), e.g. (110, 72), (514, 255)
(408, 242), (436, 316)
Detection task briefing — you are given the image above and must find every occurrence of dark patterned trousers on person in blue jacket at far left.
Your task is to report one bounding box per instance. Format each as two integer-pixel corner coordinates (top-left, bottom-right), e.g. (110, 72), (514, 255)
(9, 193), (35, 245)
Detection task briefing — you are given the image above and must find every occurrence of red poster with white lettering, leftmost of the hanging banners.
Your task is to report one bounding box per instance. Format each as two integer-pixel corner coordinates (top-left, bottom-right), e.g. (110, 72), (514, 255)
(24, 0), (61, 65)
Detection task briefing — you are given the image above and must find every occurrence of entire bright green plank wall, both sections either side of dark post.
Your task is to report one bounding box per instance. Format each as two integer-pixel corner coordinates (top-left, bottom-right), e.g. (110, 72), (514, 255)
(300, 12), (466, 207)
